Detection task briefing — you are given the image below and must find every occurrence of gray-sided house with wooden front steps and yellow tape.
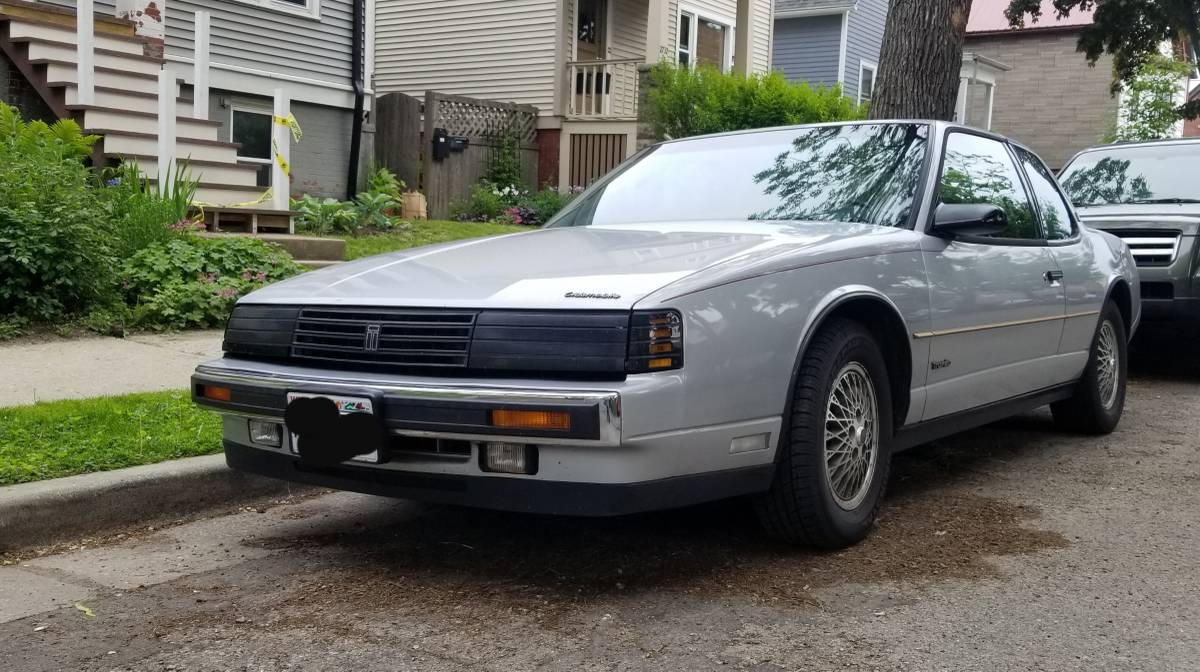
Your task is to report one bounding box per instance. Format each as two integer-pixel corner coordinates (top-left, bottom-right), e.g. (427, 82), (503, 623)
(0, 0), (371, 226)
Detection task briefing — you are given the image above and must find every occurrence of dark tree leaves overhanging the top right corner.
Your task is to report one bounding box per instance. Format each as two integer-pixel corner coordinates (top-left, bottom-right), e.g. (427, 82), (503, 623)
(1004, 0), (1200, 119)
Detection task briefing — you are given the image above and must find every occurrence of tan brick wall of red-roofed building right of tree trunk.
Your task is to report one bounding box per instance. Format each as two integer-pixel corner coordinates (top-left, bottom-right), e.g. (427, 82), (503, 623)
(964, 30), (1117, 169)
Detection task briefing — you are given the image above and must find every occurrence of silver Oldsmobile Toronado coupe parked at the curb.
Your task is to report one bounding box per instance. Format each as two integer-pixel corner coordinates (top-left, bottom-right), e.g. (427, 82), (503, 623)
(192, 121), (1141, 548)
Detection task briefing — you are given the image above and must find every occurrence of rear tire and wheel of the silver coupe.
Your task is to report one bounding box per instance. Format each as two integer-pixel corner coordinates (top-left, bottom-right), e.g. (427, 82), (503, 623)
(1050, 302), (1128, 434)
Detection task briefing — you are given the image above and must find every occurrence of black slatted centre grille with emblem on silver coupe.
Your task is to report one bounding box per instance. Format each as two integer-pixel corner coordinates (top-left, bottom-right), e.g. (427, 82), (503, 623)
(292, 308), (476, 368)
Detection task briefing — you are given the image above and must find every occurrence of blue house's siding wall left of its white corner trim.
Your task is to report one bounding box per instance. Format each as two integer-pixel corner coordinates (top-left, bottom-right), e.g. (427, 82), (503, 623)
(772, 14), (841, 86)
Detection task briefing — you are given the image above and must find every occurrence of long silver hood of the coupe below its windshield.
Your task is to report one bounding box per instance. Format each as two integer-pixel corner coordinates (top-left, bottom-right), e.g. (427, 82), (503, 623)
(242, 221), (911, 310)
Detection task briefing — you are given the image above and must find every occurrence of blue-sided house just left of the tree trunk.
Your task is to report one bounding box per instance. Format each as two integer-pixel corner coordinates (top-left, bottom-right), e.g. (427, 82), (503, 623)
(772, 0), (888, 103)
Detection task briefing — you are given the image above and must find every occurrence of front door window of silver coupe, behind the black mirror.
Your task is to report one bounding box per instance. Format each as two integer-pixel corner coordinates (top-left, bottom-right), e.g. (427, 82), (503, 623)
(937, 133), (1039, 240)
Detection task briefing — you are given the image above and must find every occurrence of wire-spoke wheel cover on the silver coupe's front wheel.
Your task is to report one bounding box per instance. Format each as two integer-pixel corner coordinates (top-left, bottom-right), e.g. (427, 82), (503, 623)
(824, 361), (883, 511)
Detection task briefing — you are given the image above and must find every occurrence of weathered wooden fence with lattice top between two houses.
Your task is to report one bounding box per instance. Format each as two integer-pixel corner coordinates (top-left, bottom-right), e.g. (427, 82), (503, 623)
(376, 91), (538, 220)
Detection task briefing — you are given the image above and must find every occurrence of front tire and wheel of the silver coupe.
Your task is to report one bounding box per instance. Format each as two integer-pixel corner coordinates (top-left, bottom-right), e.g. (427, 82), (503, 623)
(755, 318), (892, 550)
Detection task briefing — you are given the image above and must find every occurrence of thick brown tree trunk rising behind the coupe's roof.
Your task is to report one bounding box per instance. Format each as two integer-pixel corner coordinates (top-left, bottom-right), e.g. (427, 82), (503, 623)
(870, 0), (971, 120)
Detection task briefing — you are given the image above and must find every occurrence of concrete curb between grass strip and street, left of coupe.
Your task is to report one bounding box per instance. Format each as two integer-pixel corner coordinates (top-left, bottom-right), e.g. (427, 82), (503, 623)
(0, 455), (312, 552)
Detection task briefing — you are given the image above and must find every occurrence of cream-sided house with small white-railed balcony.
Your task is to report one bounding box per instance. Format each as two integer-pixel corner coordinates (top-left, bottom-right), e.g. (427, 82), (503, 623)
(374, 0), (773, 187)
